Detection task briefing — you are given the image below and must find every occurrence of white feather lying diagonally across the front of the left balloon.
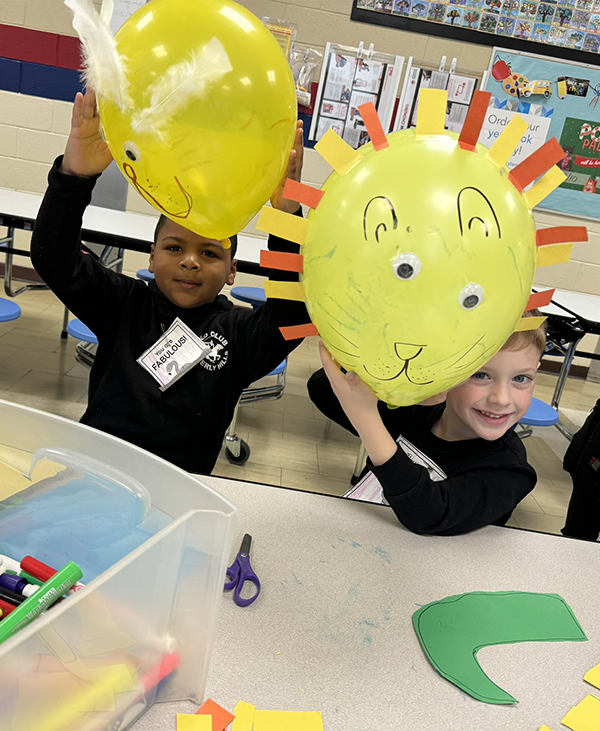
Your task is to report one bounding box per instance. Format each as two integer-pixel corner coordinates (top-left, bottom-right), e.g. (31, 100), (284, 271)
(133, 37), (233, 136)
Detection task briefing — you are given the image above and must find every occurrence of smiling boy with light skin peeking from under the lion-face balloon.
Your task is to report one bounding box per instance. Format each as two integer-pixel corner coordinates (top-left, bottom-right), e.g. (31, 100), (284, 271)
(308, 311), (546, 535)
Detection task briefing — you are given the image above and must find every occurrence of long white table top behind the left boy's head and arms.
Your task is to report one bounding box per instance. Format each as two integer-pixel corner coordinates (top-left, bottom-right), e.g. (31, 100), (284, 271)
(0, 188), (267, 264)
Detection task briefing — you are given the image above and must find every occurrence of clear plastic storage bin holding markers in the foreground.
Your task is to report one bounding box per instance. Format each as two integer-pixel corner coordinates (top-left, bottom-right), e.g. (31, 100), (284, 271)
(0, 401), (235, 731)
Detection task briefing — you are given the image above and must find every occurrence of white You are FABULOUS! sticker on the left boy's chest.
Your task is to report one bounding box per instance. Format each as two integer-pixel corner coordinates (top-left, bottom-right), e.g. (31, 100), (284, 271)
(137, 317), (211, 391)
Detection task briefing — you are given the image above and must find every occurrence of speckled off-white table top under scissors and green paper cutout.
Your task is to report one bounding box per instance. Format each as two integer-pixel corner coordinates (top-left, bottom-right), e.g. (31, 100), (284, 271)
(134, 478), (600, 731)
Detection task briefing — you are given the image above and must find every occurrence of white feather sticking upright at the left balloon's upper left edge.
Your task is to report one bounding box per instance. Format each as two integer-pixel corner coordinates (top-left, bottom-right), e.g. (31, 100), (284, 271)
(64, 0), (130, 109)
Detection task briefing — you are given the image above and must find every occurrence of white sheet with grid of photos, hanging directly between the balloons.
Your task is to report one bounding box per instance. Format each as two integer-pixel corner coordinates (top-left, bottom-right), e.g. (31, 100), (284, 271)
(309, 43), (404, 149)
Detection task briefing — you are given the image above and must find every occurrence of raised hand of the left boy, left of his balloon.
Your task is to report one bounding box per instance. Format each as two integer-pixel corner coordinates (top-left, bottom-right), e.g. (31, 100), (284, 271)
(61, 89), (113, 178)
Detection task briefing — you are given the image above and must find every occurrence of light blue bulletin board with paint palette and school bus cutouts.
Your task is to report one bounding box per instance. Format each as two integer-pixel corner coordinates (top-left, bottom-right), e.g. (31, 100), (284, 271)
(480, 48), (600, 220)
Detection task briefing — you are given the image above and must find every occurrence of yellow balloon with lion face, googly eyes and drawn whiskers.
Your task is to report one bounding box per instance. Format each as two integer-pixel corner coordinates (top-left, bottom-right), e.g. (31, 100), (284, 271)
(302, 130), (536, 406)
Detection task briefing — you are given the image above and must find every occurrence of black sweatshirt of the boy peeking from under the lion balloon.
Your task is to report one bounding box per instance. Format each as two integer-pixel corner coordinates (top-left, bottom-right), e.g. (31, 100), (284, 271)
(308, 370), (537, 536)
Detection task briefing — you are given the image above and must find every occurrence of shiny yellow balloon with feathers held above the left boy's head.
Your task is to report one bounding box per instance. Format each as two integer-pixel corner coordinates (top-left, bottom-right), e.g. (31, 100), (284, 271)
(96, 0), (297, 238)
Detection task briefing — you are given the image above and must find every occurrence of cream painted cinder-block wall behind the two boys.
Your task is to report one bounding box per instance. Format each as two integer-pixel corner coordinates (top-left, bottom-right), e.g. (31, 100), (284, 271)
(0, 0), (600, 304)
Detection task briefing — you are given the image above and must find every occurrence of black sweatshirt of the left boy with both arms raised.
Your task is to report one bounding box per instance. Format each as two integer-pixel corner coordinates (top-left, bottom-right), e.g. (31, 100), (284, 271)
(31, 157), (308, 474)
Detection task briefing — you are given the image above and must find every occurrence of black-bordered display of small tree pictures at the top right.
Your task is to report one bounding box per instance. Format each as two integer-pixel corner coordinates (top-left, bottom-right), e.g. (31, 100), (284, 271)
(350, 0), (600, 64)
